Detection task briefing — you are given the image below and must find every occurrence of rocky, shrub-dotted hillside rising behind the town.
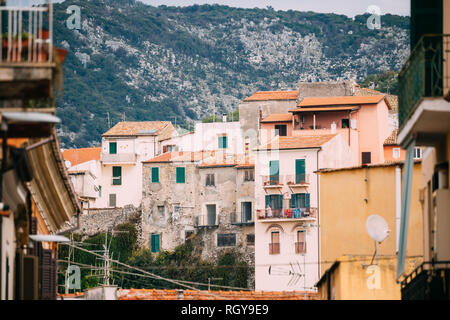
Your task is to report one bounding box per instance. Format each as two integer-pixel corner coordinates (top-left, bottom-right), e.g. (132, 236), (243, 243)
(54, 0), (409, 147)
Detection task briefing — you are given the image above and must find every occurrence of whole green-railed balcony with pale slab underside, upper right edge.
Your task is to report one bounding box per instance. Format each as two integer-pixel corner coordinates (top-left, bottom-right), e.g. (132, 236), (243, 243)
(398, 35), (450, 145)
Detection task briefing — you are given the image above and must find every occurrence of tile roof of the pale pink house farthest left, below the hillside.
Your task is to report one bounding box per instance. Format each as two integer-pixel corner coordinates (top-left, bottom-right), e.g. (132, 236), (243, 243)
(102, 121), (173, 139)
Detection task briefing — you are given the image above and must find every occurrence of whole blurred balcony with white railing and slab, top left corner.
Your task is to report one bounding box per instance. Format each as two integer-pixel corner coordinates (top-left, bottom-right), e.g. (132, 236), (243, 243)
(0, 0), (61, 100)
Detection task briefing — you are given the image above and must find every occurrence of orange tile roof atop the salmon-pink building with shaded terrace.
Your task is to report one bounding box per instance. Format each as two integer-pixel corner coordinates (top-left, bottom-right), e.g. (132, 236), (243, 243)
(289, 94), (390, 111)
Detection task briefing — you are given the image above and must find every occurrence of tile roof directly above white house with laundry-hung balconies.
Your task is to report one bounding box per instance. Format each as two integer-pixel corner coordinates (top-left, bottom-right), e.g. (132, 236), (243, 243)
(255, 134), (336, 150)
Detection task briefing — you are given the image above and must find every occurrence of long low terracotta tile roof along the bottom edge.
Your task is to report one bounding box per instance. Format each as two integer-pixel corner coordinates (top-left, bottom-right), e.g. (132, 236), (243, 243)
(117, 289), (318, 300)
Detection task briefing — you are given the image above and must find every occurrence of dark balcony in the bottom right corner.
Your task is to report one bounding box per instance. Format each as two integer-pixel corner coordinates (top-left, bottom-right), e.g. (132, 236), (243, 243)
(401, 261), (450, 300)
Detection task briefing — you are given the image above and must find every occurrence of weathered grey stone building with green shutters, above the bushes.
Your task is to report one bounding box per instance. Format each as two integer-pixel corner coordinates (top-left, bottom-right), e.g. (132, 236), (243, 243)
(142, 151), (254, 284)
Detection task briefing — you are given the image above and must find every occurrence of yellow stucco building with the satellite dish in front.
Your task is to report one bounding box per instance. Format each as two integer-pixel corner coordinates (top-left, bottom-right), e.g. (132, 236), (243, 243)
(317, 161), (423, 300)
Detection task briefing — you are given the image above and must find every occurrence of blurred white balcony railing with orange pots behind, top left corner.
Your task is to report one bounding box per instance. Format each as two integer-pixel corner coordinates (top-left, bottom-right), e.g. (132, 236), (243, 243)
(0, 0), (53, 65)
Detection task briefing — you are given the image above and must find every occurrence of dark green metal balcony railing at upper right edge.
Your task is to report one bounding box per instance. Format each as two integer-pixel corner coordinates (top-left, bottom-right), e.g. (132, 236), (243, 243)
(398, 34), (450, 127)
